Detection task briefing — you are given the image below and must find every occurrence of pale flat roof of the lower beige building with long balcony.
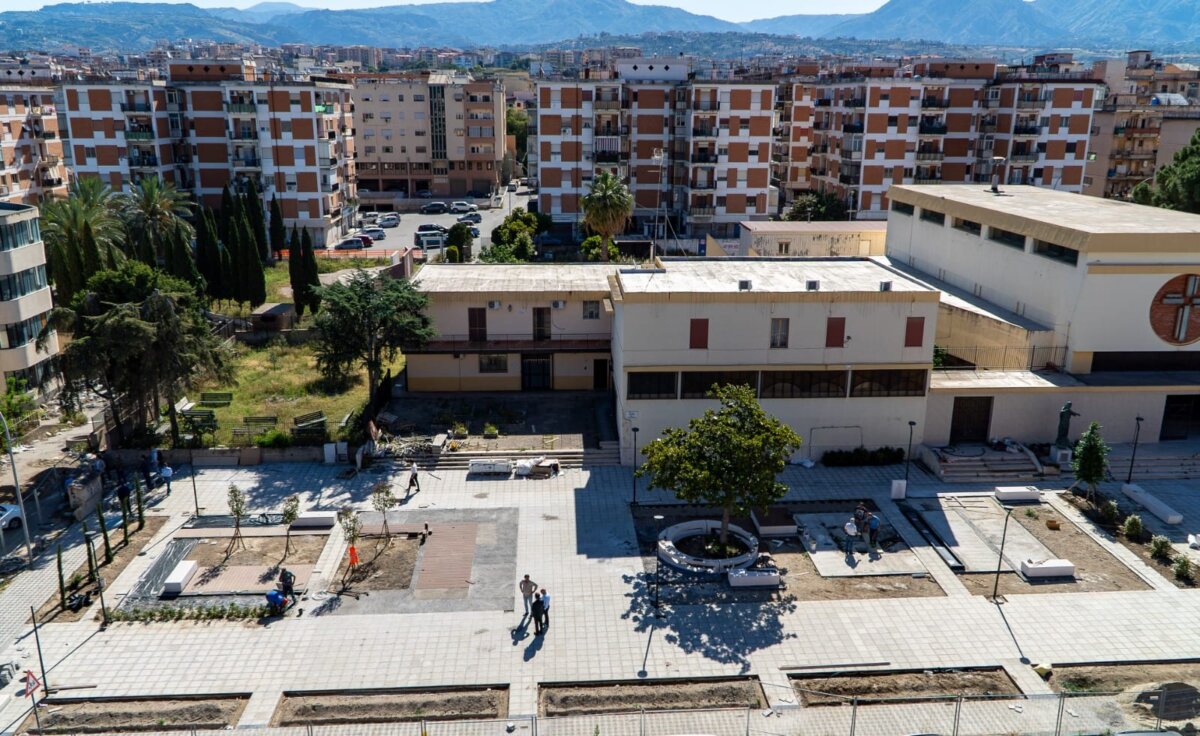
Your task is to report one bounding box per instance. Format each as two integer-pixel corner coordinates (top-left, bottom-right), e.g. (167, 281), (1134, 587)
(413, 263), (620, 294)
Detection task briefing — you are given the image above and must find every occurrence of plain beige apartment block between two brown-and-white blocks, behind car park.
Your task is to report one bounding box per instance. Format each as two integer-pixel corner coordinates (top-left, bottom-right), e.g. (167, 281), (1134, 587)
(343, 72), (508, 198)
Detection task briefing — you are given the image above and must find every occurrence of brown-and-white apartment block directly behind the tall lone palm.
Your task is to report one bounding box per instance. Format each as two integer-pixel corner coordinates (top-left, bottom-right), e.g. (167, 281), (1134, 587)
(529, 58), (774, 240)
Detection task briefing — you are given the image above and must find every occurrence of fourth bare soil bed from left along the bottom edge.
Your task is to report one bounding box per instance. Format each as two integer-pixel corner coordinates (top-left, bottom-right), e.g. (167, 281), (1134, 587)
(792, 668), (1021, 706)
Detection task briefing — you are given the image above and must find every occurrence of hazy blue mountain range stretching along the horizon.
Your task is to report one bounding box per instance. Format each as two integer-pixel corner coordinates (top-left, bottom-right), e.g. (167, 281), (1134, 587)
(0, 0), (1200, 50)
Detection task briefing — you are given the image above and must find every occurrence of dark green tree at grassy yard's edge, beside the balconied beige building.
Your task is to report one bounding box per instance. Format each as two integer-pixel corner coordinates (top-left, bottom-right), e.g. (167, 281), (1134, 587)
(313, 269), (434, 391)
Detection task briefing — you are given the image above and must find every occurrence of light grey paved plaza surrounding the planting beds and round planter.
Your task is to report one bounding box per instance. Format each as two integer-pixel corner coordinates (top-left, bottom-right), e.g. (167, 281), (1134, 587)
(0, 465), (1200, 736)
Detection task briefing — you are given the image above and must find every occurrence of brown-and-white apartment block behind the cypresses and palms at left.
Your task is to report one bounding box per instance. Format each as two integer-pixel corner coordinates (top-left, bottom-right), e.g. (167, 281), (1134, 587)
(64, 60), (356, 246)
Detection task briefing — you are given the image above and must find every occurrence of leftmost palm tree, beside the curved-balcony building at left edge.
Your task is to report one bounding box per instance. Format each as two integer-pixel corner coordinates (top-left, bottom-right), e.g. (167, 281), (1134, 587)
(42, 176), (125, 305)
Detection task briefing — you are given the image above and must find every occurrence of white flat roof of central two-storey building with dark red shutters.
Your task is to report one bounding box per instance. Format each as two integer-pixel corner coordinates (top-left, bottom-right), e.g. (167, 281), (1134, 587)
(617, 257), (937, 295)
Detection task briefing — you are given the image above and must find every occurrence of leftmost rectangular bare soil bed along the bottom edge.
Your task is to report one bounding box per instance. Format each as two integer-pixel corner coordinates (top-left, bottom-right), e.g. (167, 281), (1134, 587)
(19, 696), (246, 734)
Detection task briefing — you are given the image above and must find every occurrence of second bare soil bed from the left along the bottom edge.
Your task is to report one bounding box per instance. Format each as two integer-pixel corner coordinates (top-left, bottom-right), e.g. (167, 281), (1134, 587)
(271, 688), (509, 726)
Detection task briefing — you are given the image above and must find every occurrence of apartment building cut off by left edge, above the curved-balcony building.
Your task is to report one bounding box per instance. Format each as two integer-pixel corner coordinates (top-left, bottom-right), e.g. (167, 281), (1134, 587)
(0, 83), (67, 205)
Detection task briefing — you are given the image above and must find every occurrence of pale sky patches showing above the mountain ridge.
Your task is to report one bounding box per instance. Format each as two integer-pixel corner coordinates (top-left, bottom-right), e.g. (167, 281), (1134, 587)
(0, 0), (884, 22)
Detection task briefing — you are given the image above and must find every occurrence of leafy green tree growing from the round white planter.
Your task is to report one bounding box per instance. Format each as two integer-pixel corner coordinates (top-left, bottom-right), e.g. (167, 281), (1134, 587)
(637, 385), (800, 546)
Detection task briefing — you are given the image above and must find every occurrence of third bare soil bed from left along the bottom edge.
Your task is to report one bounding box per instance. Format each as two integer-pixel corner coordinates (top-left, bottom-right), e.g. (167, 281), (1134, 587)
(538, 678), (767, 716)
